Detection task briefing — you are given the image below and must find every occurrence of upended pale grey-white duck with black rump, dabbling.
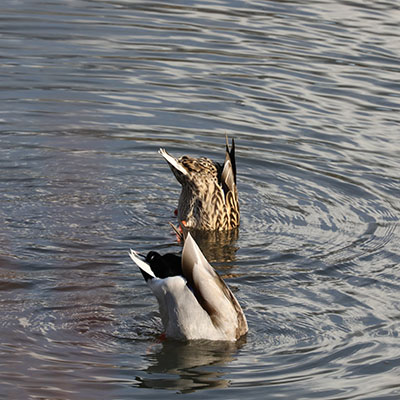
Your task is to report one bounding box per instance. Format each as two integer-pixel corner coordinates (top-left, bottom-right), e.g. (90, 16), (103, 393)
(129, 233), (248, 341)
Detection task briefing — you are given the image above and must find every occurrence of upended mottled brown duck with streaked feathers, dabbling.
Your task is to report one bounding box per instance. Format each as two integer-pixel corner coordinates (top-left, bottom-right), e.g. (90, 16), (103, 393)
(159, 139), (240, 231)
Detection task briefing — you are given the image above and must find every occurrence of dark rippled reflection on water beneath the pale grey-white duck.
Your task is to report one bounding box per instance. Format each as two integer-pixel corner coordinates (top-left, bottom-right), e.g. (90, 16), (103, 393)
(137, 338), (246, 393)
